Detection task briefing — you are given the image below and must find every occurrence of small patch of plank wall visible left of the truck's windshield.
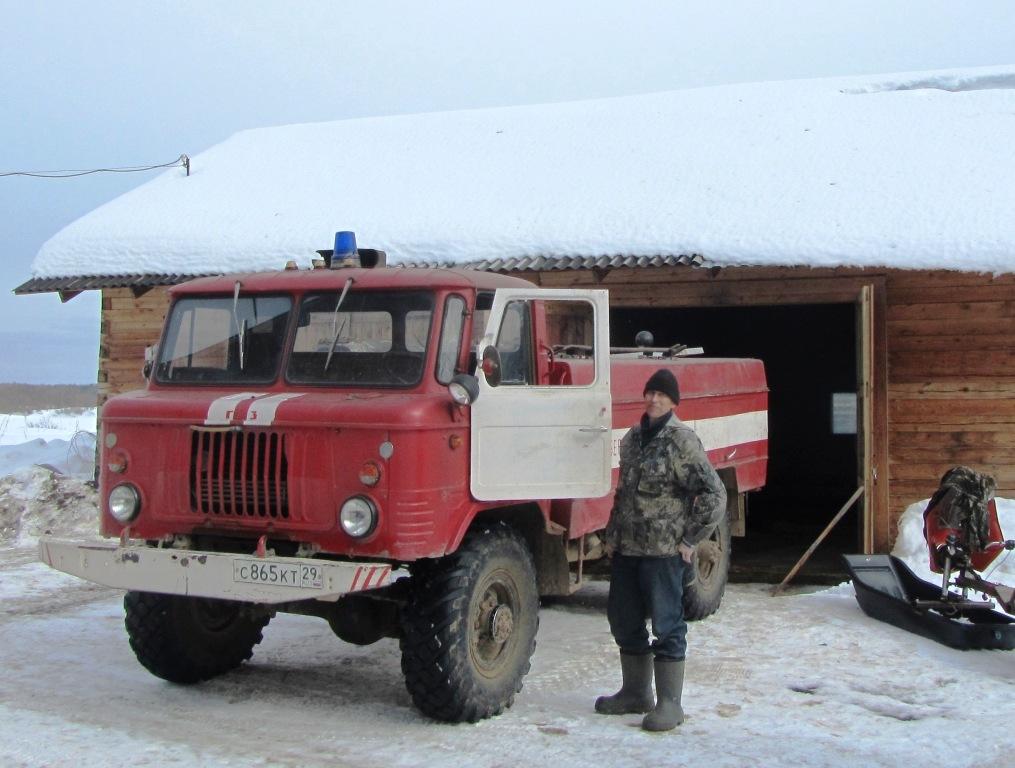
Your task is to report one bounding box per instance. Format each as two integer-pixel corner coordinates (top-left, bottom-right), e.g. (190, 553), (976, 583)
(98, 288), (170, 408)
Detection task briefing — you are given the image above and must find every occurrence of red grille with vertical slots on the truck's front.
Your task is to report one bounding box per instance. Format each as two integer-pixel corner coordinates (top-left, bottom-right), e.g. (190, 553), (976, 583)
(190, 428), (289, 519)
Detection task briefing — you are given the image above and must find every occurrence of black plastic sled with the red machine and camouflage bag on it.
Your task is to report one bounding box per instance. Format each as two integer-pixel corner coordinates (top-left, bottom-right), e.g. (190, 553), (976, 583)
(843, 467), (1015, 650)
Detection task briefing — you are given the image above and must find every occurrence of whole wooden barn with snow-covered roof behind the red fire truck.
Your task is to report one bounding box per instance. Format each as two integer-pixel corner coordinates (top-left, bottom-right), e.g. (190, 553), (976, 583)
(16, 67), (1015, 572)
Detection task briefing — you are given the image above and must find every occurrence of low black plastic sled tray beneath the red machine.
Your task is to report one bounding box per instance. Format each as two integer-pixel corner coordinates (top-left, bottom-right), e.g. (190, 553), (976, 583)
(842, 555), (1015, 650)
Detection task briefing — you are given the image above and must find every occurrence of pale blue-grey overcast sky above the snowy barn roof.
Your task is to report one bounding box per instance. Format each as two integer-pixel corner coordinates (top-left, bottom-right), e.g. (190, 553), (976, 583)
(0, 0), (1015, 383)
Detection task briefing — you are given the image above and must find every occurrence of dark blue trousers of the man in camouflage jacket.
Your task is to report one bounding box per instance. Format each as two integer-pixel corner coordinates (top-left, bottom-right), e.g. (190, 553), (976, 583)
(606, 554), (688, 660)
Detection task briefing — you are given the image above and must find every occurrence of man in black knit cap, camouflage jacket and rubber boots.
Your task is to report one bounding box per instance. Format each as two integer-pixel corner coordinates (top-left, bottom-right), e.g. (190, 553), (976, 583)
(596, 368), (726, 730)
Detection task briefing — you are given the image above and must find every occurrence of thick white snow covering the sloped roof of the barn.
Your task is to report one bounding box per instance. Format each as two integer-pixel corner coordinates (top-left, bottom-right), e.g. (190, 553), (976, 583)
(32, 65), (1015, 278)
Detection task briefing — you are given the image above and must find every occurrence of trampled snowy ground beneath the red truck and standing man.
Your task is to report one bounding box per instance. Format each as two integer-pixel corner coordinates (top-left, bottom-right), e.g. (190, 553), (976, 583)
(0, 413), (1015, 768)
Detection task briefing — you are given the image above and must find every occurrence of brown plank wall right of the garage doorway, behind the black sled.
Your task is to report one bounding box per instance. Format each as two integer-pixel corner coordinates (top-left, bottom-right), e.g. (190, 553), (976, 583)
(886, 271), (1015, 539)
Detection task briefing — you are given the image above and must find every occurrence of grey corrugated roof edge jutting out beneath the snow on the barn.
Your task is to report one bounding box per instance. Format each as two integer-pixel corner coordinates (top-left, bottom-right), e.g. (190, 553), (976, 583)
(14, 254), (705, 295)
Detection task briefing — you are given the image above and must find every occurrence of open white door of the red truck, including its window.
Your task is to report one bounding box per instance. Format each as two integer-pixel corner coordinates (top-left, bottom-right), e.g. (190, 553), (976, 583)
(471, 288), (612, 500)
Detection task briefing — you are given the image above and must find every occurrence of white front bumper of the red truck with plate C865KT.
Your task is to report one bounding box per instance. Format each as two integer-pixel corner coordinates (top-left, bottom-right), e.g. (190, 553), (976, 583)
(39, 537), (392, 605)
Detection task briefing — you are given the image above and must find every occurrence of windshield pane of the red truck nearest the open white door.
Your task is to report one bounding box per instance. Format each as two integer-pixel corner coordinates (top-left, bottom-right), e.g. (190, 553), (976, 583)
(286, 285), (433, 387)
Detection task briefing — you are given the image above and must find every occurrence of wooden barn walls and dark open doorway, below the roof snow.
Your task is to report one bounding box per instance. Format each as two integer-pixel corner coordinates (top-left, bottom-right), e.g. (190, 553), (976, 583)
(17, 258), (1015, 568)
